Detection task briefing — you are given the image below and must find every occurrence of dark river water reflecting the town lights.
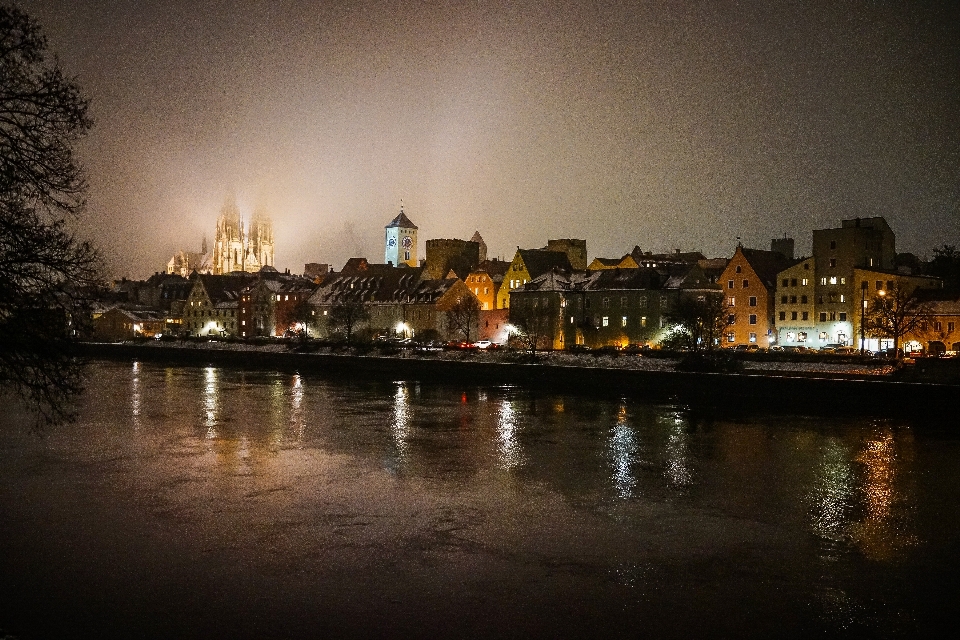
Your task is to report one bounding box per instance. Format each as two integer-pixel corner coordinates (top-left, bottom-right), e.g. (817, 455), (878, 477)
(0, 363), (960, 638)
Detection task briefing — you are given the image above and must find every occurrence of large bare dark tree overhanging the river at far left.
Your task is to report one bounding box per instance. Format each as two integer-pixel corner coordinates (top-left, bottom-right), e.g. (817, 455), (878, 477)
(0, 6), (99, 424)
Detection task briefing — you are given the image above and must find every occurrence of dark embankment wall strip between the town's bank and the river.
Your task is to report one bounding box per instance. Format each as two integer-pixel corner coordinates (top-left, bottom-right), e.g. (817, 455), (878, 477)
(71, 343), (960, 420)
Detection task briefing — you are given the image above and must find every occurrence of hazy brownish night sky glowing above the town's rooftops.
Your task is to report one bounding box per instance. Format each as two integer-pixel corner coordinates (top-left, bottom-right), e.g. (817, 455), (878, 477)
(19, 0), (960, 277)
